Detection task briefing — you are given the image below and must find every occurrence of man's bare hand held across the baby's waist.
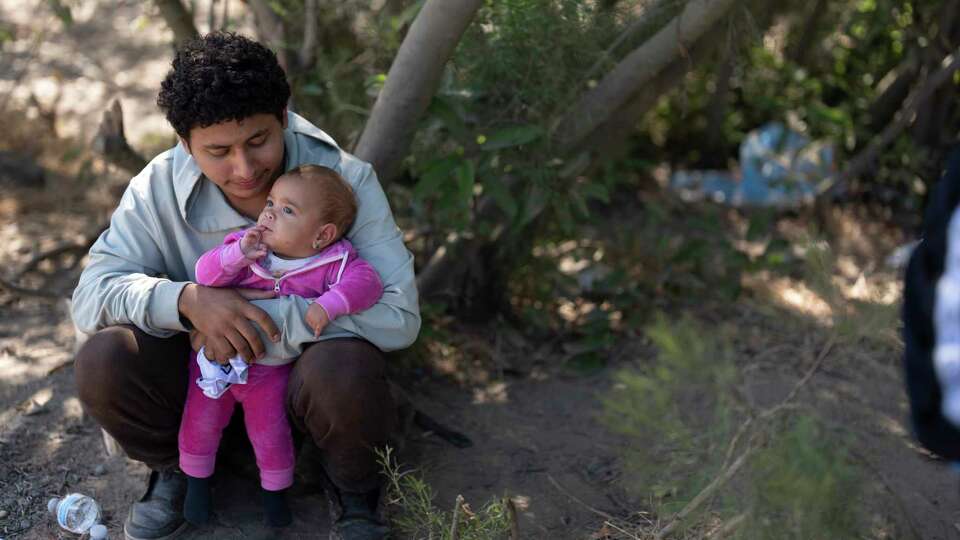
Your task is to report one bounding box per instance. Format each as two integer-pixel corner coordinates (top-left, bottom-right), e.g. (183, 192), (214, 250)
(178, 283), (280, 364)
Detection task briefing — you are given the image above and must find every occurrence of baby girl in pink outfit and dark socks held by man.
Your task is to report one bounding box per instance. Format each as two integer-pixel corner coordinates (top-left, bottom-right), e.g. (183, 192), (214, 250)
(179, 165), (383, 526)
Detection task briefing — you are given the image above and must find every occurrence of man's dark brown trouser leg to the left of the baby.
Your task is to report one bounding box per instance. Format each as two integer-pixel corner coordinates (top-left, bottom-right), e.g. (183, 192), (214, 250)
(74, 326), (190, 469)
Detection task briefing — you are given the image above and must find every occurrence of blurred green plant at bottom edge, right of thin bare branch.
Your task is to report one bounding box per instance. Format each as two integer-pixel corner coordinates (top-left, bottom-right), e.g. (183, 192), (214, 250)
(738, 416), (863, 540)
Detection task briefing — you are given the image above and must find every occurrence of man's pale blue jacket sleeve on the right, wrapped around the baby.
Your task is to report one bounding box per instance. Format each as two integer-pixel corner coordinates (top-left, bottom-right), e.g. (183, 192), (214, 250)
(253, 160), (420, 358)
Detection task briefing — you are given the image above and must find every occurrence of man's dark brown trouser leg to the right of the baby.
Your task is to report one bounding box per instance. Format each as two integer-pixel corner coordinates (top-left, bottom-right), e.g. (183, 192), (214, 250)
(287, 339), (398, 493)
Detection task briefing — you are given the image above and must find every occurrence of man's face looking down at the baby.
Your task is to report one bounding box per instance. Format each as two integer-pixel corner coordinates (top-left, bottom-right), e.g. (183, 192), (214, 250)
(185, 111), (286, 216)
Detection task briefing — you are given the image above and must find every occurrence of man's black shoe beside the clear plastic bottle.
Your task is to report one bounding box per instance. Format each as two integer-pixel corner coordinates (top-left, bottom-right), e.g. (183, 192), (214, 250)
(123, 469), (187, 540)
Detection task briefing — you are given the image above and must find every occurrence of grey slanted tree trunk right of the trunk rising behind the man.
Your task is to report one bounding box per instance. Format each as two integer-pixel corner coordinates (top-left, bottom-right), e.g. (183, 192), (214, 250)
(556, 0), (736, 153)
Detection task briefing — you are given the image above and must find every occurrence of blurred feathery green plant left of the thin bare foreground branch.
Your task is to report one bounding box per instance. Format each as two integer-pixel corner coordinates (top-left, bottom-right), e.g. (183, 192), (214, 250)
(603, 316), (738, 511)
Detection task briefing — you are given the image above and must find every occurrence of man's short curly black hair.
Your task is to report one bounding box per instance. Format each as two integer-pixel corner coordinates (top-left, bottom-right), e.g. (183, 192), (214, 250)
(157, 32), (290, 140)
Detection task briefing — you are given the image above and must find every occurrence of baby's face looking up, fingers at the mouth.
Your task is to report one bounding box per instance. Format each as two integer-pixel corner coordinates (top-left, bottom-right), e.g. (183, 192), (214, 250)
(257, 175), (324, 257)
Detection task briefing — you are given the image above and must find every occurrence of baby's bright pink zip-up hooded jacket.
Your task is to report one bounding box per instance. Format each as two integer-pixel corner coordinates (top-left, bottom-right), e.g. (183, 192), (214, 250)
(197, 230), (383, 321)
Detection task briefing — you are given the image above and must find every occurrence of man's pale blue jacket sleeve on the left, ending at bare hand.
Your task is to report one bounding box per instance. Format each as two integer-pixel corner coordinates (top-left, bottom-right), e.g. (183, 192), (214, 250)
(71, 169), (188, 337)
